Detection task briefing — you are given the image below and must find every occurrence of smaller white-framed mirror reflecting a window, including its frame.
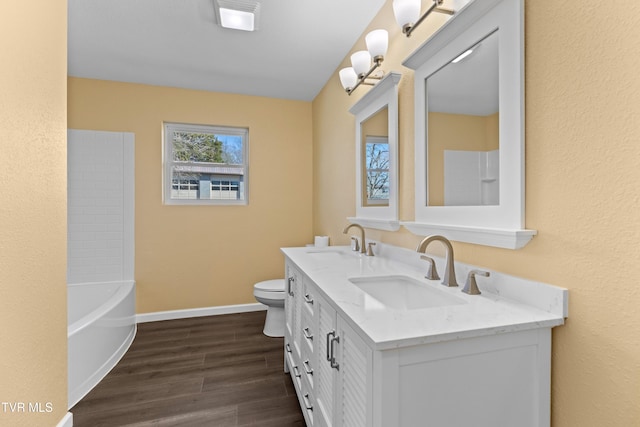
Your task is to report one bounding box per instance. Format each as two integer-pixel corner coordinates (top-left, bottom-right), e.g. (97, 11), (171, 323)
(347, 72), (401, 231)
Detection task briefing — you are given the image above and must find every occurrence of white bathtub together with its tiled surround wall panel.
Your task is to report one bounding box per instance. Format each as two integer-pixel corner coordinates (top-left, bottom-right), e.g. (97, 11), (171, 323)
(67, 129), (136, 408)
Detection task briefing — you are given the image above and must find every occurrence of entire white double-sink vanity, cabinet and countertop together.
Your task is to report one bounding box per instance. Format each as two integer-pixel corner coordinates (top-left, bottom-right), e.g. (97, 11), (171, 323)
(282, 242), (567, 427)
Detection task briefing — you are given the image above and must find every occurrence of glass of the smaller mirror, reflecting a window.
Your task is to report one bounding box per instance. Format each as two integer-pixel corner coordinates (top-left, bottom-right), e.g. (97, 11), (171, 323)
(360, 106), (389, 206)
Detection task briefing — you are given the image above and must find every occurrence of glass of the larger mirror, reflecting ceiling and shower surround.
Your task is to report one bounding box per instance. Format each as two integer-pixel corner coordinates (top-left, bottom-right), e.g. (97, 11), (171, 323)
(425, 31), (500, 206)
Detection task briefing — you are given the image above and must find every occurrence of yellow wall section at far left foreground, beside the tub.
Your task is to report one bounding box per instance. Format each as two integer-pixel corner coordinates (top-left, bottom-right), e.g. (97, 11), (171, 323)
(0, 0), (67, 427)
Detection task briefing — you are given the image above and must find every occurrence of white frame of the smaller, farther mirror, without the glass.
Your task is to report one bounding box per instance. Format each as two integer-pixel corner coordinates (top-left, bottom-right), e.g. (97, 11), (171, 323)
(347, 71), (402, 231)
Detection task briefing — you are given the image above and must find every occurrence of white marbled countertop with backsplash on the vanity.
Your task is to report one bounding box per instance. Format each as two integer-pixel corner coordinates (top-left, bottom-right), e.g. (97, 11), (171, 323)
(282, 246), (567, 350)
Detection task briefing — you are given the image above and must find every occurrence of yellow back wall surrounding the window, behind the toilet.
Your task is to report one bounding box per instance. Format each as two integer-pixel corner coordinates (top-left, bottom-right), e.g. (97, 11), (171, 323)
(68, 78), (312, 313)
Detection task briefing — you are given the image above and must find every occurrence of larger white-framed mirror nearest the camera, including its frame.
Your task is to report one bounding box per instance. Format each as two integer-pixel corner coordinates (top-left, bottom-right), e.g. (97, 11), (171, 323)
(403, 0), (536, 249)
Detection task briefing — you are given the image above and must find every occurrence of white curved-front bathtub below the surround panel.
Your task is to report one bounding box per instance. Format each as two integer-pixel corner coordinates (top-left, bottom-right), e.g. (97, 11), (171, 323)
(67, 281), (136, 408)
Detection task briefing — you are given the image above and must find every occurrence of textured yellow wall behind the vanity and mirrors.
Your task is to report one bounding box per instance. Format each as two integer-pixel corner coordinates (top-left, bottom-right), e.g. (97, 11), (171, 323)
(313, 0), (640, 427)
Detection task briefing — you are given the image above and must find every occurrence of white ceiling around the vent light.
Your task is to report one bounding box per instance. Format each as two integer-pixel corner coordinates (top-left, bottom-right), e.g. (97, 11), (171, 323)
(68, 0), (385, 101)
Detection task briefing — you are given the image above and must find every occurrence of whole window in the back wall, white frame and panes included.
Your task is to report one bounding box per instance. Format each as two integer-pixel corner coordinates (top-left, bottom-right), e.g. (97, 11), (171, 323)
(163, 123), (249, 205)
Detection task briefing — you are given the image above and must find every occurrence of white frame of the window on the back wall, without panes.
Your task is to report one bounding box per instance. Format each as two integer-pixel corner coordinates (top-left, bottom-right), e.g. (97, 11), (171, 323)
(162, 122), (249, 205)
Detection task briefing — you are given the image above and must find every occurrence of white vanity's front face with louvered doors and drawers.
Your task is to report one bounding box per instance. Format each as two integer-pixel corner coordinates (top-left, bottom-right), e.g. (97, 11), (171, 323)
(285, 264), (372, 427)
